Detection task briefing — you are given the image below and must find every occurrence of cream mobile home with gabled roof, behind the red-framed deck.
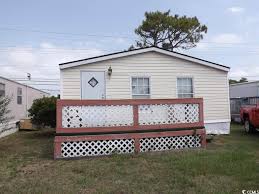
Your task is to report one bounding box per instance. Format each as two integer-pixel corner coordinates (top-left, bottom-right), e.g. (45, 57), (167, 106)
(60, 47), (230, 134)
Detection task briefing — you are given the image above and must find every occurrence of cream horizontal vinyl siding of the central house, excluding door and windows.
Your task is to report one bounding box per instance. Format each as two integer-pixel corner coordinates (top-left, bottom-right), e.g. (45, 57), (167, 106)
(61, 52), (230, 121)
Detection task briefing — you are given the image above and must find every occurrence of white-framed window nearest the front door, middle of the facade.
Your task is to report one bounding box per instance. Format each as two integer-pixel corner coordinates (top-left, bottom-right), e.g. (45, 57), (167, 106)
(131, 77), (150, 98)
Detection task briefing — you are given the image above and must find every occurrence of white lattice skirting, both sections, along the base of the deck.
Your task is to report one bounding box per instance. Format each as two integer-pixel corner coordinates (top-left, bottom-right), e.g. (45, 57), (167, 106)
(61, 135), (201, 158)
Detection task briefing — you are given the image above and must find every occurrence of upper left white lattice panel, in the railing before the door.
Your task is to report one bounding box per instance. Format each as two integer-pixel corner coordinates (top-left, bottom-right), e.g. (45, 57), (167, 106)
(62, 105), (133, 128)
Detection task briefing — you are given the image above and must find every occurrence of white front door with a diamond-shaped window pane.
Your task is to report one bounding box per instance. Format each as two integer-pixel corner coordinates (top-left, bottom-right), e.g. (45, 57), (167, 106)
(81, 71), (105, 99)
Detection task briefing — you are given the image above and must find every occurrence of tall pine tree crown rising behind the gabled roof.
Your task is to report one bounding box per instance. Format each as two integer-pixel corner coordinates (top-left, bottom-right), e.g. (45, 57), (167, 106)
(135, 10), (207, 51)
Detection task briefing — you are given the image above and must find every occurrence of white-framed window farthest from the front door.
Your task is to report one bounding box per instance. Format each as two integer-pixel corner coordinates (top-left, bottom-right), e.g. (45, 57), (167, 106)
(177, 77), (193, 98)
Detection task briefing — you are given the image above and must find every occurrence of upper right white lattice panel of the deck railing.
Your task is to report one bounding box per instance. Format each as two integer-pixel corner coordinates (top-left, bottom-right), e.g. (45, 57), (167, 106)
(138, 104), (199, 125)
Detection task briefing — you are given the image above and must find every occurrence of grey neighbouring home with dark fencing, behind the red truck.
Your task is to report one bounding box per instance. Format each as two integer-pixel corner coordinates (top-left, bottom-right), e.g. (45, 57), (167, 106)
(229, 81), (259, 122)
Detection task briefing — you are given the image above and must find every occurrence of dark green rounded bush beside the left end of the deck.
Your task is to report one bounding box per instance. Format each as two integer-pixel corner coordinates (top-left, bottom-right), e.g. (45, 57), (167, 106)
(28, 96), (57, 128)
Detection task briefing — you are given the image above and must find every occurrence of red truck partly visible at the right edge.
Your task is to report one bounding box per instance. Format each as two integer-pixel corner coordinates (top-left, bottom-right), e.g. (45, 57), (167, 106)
(240, 103), (259, 133)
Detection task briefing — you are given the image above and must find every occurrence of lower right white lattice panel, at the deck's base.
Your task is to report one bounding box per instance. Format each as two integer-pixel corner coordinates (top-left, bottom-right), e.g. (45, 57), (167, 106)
(140, 135), (201, 152)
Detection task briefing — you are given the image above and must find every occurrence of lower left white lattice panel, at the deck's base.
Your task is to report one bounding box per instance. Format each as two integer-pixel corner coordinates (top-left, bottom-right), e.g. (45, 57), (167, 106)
(61, 139), (134, 158)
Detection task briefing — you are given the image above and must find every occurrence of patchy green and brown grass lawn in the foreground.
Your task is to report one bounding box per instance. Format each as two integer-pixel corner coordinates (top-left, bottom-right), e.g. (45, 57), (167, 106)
(0, 125), (259, 193)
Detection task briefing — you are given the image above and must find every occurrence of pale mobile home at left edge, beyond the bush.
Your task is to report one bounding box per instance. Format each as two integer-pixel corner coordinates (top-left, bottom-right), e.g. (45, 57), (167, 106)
(0, 76), (49, 137)
